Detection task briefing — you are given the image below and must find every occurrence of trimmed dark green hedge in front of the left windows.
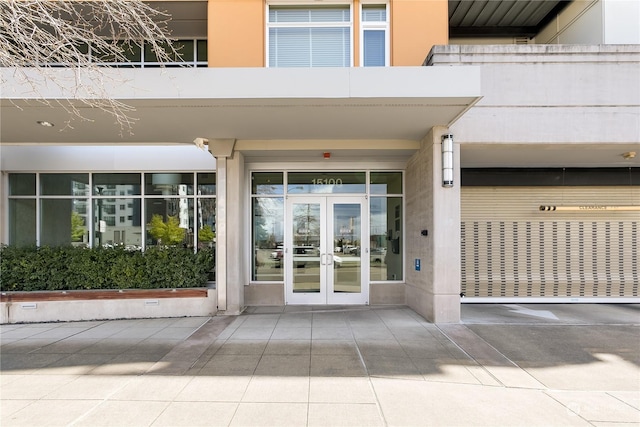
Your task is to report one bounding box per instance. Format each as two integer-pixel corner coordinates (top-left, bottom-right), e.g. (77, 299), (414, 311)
(0, 246), (214, 291)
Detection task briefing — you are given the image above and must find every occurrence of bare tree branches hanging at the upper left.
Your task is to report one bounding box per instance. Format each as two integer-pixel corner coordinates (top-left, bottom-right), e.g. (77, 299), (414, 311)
(0, 0), (180, 133)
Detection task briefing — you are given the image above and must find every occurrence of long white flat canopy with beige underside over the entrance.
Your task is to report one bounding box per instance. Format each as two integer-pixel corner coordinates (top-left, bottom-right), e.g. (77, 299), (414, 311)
(0, 66), (480, 163)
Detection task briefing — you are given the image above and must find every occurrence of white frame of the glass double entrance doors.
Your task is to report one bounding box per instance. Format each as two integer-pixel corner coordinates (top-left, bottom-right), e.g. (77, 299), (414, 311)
(282, 194), (369, 305)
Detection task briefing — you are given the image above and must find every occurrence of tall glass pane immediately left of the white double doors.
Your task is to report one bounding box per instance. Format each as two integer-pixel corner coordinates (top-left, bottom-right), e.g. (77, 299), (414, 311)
(251, 197), (284, 281)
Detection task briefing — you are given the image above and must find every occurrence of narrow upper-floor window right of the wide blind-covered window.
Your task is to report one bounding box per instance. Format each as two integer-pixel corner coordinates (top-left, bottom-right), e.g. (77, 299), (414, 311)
(360, 4), (389, 67)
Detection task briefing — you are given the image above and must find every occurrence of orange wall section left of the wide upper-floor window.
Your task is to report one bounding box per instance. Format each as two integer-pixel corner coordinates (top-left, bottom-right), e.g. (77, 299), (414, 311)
(207, 0), (265, 67)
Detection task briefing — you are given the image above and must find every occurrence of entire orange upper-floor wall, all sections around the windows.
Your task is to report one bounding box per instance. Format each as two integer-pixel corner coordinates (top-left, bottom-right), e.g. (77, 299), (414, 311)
(208, 0), (449, 67)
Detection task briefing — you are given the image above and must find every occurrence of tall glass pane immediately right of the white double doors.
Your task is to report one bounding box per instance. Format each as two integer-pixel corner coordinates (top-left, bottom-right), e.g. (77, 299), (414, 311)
(369, 197), (403, 281)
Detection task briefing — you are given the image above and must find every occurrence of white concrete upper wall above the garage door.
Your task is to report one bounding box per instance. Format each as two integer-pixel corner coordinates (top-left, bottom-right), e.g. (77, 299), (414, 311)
(430, 45), (640, 145)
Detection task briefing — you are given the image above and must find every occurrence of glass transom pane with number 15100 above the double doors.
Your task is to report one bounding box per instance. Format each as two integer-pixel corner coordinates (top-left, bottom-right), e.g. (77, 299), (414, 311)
(287, 172), (367, 194)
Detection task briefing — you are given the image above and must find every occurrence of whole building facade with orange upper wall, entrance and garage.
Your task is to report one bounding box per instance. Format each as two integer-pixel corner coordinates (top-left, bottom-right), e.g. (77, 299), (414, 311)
(0, 0), (640, 322)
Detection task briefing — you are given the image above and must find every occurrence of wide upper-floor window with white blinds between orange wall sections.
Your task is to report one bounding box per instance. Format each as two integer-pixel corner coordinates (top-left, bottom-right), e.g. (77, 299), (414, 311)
(267, 4), (352, 67)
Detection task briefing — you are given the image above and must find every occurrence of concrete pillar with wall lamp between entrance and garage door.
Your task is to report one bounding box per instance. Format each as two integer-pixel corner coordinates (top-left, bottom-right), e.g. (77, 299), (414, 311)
(405, 126), (460, 323)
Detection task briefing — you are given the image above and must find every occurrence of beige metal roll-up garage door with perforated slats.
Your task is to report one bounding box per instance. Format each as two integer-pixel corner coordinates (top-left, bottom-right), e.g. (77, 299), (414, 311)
(461, 186), (640, 302)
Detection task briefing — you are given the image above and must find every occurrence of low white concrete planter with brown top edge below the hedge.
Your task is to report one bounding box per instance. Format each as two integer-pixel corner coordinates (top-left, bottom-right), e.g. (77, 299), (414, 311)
(0, 288), (217, 324)
